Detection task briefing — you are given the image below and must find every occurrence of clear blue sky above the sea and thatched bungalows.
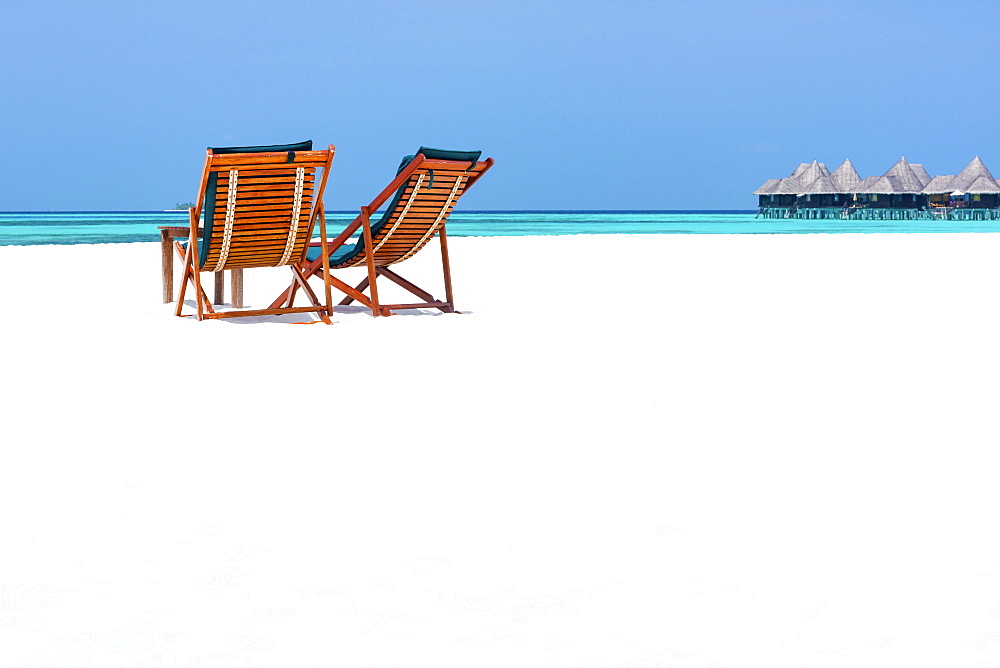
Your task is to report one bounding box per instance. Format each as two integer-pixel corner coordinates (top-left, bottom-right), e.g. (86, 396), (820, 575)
(0, 0), (1000, 210)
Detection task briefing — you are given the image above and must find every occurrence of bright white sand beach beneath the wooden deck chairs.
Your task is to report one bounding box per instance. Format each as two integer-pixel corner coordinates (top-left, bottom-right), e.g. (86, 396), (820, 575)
(0, 234), (1000, 668)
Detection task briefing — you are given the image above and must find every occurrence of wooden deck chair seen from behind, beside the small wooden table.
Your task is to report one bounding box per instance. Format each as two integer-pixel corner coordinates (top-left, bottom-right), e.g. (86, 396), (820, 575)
(175, 141), (334, 324)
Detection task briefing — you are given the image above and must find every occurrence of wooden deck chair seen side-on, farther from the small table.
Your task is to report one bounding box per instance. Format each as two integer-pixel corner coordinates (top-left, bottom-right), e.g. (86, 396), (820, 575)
(272, 147), (493, 316)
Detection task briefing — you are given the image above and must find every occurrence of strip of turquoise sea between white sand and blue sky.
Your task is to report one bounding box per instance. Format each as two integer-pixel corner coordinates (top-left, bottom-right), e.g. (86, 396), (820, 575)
(0, 211), (1000, 246)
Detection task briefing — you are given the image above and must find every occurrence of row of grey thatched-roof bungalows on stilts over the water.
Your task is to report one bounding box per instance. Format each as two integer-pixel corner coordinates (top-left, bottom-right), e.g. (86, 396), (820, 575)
(754, 156), (1000, 219)
